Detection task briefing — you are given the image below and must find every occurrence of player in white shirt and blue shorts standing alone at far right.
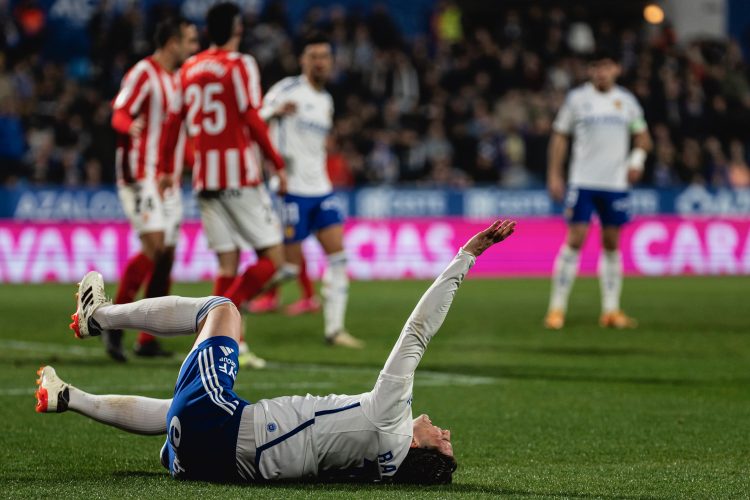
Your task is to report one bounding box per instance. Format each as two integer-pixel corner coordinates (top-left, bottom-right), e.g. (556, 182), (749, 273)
(544, 50), (651, 329)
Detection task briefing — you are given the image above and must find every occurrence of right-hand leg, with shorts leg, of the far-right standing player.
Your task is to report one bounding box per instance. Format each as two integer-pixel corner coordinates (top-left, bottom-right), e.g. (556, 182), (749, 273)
(597, 192), (638, 328)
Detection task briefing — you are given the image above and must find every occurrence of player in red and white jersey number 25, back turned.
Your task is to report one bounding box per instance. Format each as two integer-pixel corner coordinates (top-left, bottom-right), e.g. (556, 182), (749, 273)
(162, 3), (286, 366)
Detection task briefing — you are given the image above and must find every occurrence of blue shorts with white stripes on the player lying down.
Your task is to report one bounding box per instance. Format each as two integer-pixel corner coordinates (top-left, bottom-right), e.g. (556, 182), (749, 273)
(162, 337), (249, 481)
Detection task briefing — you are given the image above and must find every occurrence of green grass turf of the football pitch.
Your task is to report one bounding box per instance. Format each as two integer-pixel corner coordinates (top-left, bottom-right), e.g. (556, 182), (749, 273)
(0, 278), (750, 498)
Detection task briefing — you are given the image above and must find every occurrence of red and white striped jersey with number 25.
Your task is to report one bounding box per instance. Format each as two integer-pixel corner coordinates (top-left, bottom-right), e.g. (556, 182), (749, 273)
(162, 48), (283, 191)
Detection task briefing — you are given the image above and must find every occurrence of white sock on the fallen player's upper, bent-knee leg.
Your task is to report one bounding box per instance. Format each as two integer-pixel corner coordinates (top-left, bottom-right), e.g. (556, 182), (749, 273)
(93, 295), (231, 337)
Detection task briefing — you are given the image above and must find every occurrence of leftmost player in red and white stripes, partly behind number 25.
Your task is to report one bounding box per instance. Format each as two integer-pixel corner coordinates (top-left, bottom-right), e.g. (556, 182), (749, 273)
(104, 18), (199, 361)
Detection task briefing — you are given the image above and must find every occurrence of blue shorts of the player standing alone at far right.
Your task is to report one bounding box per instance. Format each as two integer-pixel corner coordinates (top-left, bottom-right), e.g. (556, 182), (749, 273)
(565, 188), (630, 226)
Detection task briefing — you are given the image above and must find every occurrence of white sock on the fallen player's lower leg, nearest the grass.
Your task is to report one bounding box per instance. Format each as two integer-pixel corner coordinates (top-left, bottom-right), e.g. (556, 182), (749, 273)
(68, 385), (172, 435)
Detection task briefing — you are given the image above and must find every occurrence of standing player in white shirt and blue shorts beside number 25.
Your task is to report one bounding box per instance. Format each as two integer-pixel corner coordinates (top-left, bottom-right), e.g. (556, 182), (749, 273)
(256, 35), (363, 348)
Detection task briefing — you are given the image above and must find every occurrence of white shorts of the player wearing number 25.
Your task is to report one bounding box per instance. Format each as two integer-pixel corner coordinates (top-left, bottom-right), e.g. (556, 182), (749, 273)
(198, 184), (282, 253)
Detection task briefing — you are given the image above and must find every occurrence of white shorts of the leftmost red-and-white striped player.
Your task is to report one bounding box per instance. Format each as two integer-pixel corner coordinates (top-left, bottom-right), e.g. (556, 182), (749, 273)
(117, 181), (182, 246)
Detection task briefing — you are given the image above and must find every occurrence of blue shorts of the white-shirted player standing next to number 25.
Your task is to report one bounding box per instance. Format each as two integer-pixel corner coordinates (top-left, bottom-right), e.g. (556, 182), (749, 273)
(283, 193), (344, 243)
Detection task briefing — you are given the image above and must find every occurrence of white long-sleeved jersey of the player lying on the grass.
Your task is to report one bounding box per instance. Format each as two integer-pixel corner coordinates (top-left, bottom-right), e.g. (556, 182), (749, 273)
(237, 249), (476, 480)
